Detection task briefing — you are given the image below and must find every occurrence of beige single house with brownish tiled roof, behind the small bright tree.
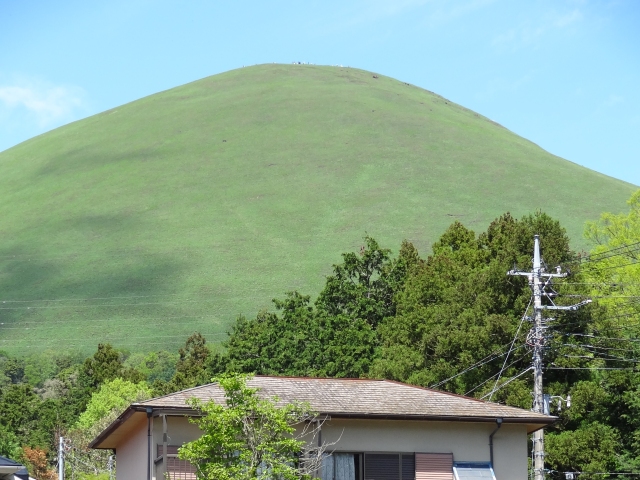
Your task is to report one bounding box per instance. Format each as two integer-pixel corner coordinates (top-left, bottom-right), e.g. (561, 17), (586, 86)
(90, 376), (556, 480)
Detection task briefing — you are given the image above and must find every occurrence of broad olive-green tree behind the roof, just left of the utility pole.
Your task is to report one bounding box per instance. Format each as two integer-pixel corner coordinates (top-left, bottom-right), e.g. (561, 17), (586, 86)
(372, 213), (588, 402)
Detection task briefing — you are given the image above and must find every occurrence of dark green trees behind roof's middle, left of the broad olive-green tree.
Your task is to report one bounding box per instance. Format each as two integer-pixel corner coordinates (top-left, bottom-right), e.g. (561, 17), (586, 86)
(213, 237), (420, 377)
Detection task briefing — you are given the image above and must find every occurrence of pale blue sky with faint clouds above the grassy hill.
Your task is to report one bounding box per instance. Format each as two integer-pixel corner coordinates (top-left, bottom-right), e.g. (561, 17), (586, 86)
(0, 0), (640, 185)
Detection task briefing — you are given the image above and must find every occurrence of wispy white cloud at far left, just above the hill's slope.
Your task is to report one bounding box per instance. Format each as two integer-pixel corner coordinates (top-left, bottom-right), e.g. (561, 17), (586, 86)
(0, 81), (84, 127)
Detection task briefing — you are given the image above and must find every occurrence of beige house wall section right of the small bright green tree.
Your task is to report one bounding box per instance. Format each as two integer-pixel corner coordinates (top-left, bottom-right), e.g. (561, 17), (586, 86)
(322, 419), (527, 480)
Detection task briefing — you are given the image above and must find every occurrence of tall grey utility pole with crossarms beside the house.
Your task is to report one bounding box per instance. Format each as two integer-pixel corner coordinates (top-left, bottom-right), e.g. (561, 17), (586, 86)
(507, 235), (591, 480)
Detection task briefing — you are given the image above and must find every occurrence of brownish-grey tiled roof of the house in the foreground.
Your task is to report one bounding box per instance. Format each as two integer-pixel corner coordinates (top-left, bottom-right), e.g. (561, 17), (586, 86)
(135, 376), (555, 424)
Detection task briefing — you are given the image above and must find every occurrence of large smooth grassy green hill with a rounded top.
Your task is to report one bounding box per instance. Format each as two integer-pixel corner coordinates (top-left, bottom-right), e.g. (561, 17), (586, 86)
(0, 65), (635, 354)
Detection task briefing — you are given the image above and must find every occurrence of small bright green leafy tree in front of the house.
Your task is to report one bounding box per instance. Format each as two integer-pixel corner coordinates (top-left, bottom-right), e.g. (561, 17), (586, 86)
(179, 375), (321, 480)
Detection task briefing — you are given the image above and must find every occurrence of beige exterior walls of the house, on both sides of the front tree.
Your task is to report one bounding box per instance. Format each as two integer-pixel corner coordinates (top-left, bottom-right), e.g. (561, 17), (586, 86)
(116, 417), (528, 480)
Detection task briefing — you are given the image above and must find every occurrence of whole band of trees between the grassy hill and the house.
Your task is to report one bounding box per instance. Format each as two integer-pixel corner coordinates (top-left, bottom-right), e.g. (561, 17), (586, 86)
(0, 192), (640, 478)
